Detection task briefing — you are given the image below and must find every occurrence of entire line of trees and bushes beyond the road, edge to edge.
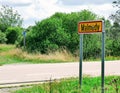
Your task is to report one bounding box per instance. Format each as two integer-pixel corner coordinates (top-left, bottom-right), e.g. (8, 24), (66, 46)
(0, 0), (120, 59)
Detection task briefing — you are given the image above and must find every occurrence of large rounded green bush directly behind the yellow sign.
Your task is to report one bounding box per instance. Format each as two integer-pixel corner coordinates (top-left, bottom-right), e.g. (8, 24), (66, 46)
(19, 10), (103, 57)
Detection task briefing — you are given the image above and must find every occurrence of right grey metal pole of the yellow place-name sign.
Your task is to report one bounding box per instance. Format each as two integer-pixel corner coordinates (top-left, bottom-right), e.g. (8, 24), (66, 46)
(101, 22), (105, 93)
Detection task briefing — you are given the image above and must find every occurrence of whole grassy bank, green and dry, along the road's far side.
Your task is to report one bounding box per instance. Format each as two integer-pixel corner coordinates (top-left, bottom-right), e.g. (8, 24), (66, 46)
(0, 44), (120, 65)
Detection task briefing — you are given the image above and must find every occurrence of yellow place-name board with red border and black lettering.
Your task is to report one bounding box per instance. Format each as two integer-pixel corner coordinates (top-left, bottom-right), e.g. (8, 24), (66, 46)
(78, 21), (102, 34)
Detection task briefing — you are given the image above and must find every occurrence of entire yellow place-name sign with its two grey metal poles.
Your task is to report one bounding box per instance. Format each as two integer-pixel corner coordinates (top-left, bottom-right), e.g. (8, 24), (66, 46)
(78, 20), (105, 93)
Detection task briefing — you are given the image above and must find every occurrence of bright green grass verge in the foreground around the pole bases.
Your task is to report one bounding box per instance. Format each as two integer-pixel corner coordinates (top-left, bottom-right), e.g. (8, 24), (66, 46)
(12, 76), (120, 93)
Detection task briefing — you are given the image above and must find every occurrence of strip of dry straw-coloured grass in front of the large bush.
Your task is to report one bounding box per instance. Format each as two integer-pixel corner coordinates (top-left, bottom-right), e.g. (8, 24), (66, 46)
(0, 44), (76, 62)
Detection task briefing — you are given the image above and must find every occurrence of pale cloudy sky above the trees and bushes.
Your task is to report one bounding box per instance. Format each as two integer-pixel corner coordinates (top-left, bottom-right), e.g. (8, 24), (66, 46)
(0, 0), (115, 27)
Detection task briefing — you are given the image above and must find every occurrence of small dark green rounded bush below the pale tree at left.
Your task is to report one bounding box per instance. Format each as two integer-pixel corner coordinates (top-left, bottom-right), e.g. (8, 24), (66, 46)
(6, 27), (22, 44)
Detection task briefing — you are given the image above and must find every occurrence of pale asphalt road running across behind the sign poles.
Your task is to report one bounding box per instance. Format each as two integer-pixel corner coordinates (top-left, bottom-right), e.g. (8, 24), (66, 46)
(0, 60), (120, 84)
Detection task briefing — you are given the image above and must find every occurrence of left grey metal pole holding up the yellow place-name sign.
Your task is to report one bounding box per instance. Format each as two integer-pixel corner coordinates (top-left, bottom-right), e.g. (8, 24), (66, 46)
(79, 34), (83, 88)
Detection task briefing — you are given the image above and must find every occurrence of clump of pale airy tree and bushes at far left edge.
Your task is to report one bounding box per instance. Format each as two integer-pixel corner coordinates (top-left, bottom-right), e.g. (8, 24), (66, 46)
(0, 5), (23, 44)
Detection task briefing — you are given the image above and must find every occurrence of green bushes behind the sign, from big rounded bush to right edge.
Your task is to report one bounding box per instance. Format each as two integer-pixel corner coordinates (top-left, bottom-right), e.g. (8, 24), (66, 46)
(14, 10), (120, 60)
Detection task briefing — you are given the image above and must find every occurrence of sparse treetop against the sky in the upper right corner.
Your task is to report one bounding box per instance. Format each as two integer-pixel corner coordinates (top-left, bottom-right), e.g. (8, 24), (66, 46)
(110, 0), (120, 23)
